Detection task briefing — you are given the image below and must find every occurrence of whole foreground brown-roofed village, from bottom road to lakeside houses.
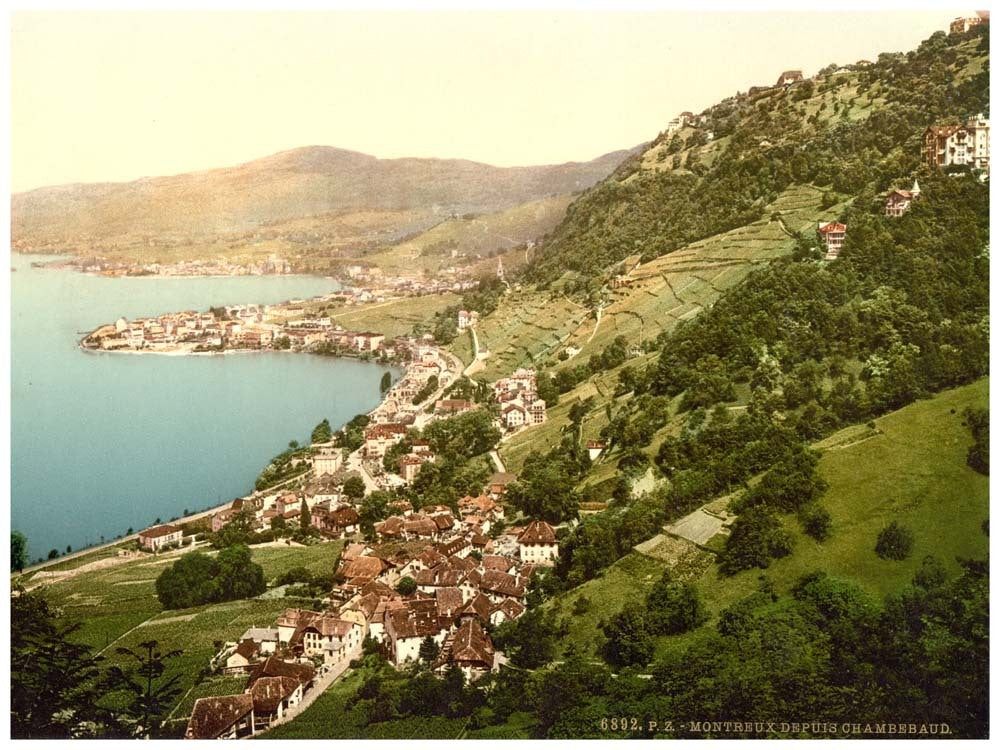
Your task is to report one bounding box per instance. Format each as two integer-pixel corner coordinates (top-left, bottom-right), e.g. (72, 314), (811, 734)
(139, 394), (559, 739)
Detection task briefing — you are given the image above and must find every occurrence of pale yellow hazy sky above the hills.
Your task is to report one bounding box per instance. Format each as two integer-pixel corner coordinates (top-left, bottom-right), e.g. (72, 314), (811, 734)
(10, 10), (956, 192)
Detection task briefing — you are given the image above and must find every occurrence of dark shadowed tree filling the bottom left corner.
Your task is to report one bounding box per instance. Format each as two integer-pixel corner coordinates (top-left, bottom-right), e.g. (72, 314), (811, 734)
(10, 587), (107, 739)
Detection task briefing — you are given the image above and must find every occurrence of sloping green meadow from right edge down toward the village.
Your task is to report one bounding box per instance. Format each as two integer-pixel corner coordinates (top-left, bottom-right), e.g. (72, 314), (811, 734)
(544, 379), (989, 656)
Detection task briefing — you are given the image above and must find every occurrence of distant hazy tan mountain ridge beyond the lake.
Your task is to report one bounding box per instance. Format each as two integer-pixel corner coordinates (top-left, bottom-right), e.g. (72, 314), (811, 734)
(11, 146), (627, 262)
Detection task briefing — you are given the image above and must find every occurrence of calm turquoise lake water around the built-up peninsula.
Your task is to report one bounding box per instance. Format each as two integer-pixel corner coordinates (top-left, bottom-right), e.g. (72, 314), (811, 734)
(11, 255), (398, 559)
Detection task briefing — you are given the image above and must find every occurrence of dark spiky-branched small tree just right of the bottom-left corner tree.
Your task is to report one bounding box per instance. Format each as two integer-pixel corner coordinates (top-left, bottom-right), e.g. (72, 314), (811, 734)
(104, 640), (182, 739)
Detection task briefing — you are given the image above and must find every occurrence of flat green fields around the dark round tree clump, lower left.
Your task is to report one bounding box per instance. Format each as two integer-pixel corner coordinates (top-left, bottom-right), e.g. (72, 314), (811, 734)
(33, 542), (343, 719)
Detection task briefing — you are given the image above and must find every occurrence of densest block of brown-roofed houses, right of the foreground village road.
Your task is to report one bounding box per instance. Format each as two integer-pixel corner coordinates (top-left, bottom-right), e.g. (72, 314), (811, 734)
(331, 520), (558, 680)
